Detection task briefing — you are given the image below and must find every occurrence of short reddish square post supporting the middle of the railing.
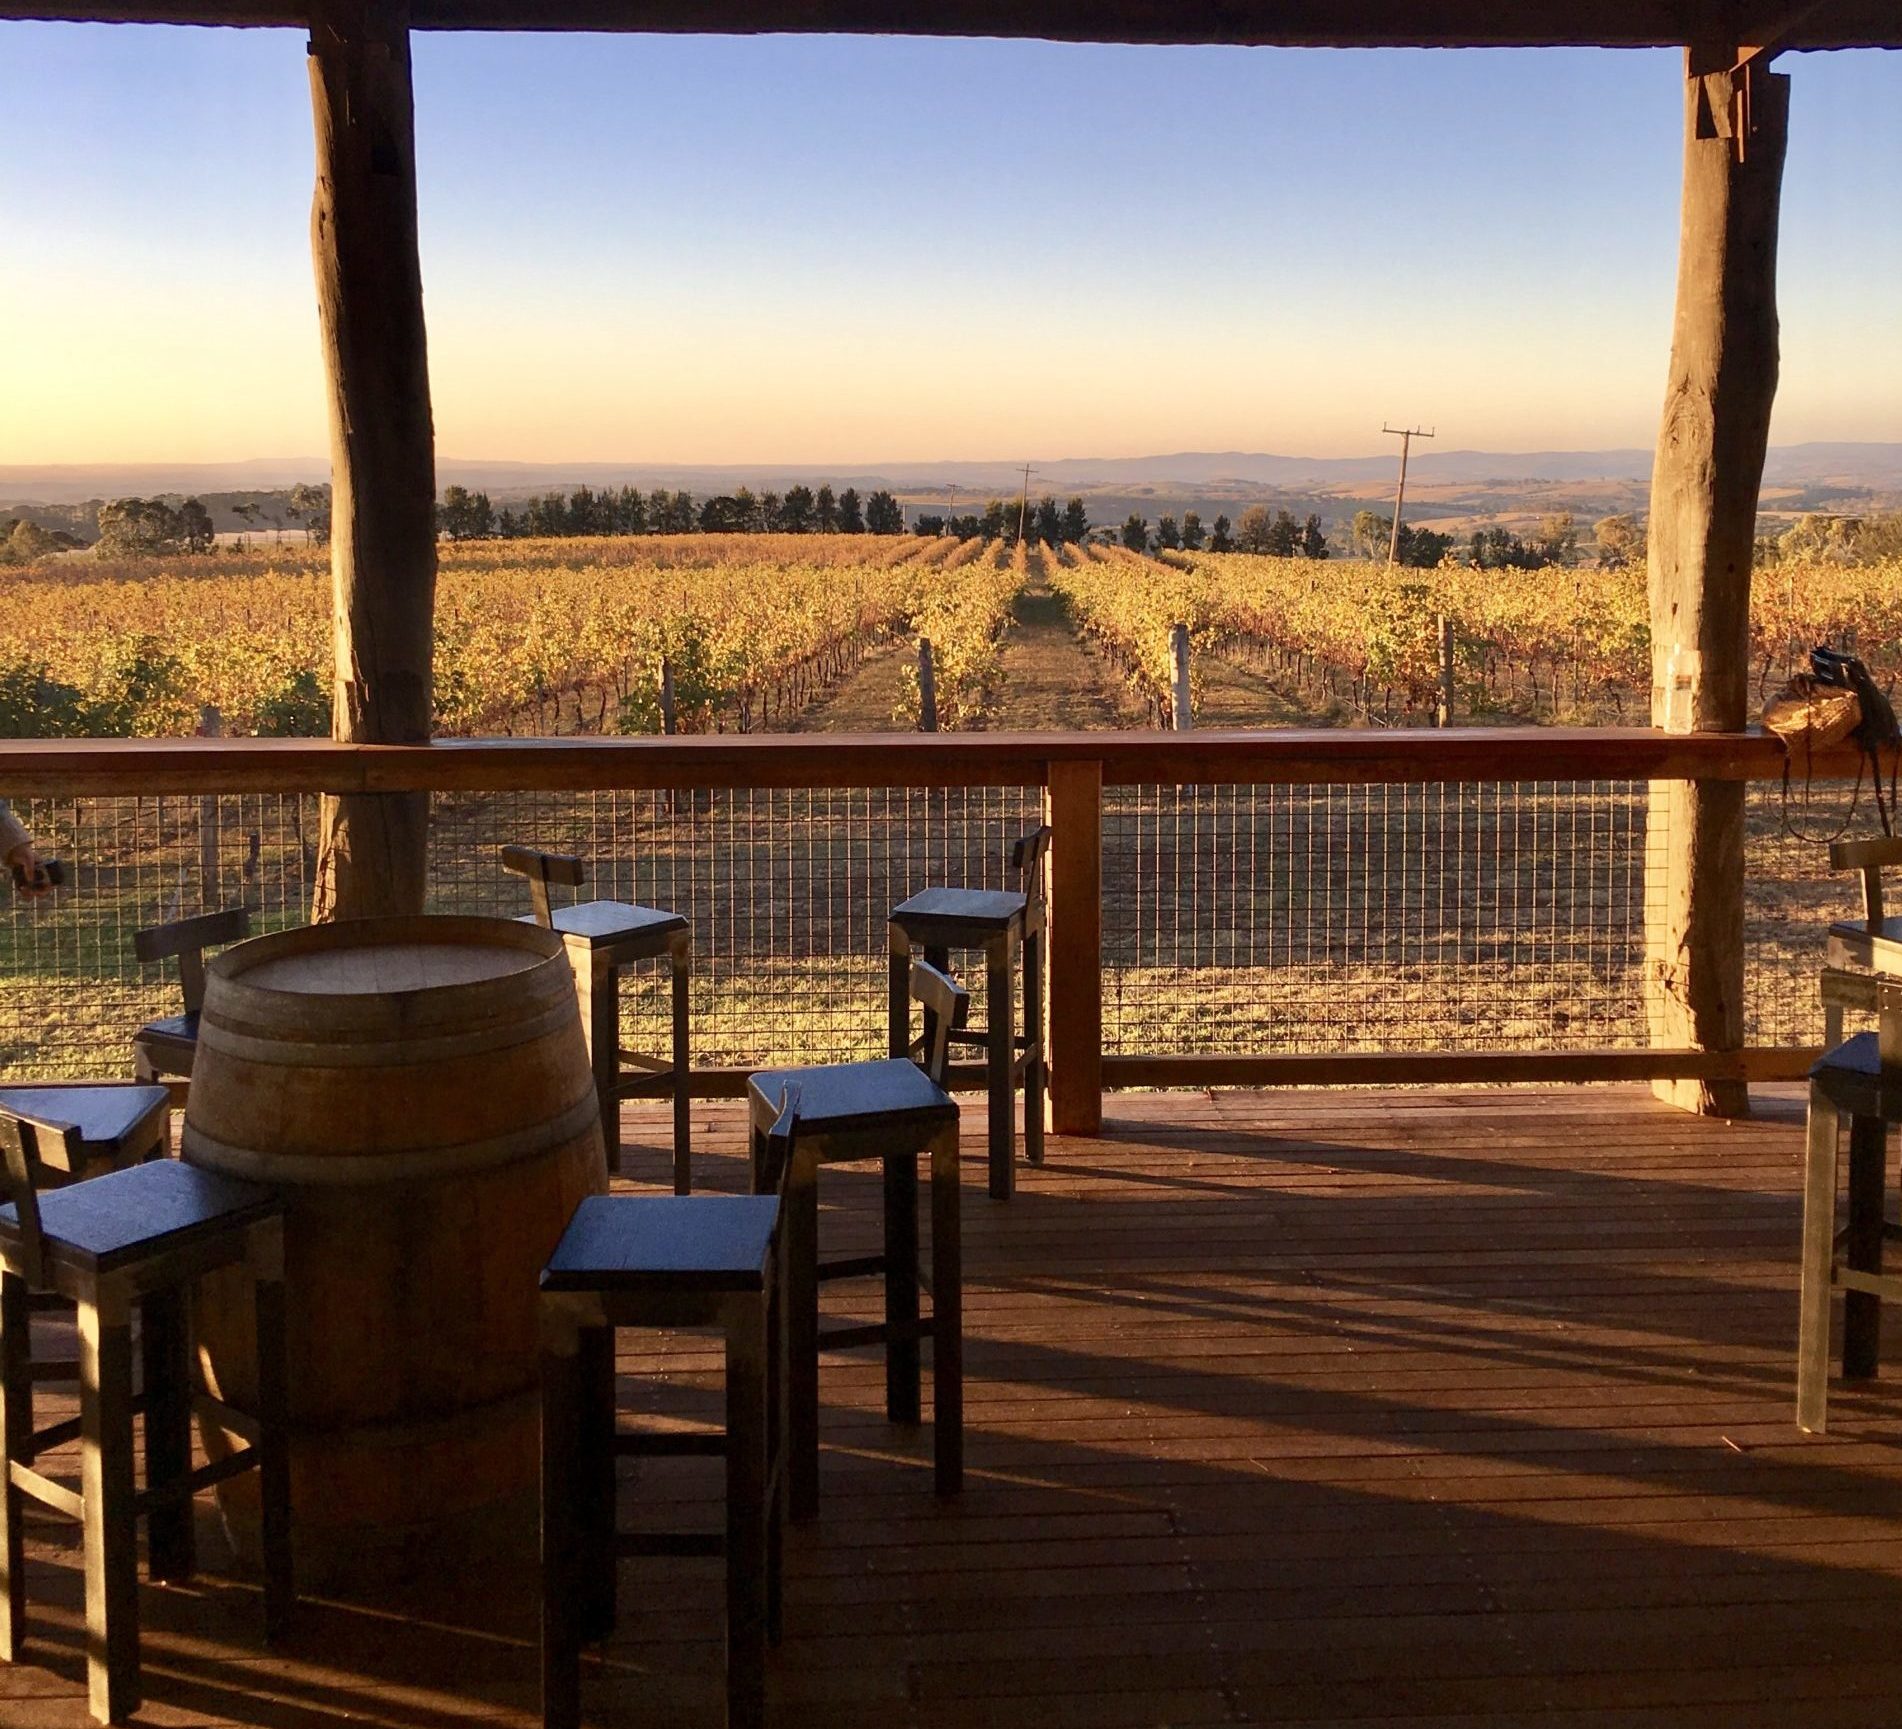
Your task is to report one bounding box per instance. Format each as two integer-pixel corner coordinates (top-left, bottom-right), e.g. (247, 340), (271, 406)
(1044, 763), (1103, 1136)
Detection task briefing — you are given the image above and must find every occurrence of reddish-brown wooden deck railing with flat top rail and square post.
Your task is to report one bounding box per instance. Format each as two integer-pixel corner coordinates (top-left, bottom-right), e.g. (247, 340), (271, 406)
(0, 729), (1856, 1132)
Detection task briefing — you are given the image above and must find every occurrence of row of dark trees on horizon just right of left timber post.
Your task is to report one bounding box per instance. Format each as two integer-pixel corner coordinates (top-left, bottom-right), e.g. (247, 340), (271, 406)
(448, 485), (905, 540)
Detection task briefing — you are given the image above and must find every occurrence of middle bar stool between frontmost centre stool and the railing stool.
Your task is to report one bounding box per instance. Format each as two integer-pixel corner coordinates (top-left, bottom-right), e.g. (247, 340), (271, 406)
(747, 962), (970, 1520)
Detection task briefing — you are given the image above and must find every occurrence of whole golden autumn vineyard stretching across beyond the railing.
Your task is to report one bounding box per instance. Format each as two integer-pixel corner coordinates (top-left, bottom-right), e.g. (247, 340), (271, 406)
(0, 534), (1902, 736)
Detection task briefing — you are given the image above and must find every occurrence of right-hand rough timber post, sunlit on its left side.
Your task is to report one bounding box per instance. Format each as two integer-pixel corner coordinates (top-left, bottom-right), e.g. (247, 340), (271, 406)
(1645, 46), (1790, 1115)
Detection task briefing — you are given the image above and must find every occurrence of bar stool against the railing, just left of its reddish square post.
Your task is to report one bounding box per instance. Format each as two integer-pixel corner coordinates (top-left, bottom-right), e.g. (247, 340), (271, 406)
(886, 827), (1050, 1200)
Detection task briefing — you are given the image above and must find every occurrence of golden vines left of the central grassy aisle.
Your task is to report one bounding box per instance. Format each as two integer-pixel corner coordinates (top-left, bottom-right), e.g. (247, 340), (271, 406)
(0, 534), (1023, 736)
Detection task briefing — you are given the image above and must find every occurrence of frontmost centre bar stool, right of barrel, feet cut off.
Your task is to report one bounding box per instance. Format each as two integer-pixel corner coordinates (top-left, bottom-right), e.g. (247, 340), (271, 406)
(542, 1103), (795, 1729)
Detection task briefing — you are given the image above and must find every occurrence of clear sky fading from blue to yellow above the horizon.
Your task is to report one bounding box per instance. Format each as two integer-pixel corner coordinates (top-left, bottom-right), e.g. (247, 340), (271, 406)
(0, 23), (1902, 464)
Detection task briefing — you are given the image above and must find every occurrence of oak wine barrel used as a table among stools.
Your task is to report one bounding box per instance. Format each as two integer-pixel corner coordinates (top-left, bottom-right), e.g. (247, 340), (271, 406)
(183, 917), (607, 1579)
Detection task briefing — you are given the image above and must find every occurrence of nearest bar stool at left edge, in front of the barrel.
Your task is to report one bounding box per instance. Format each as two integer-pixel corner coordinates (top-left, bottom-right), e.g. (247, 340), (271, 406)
(0, 1111), (293, 1723)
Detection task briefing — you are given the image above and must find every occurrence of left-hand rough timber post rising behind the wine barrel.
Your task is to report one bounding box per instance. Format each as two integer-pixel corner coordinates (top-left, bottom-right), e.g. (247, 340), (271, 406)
(310, 0), (436, 919)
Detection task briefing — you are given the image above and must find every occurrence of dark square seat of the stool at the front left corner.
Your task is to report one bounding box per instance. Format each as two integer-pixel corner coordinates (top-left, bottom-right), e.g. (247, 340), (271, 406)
(0, 1156), (281, 1272)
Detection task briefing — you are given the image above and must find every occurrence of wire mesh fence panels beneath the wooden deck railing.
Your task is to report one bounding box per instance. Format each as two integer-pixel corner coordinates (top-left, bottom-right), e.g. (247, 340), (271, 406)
(0, 782), (1870, 1080)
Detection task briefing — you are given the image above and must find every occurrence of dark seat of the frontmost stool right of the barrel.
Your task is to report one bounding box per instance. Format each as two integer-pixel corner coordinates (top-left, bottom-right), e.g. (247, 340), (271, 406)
(542, 1195), (780, 1292)
